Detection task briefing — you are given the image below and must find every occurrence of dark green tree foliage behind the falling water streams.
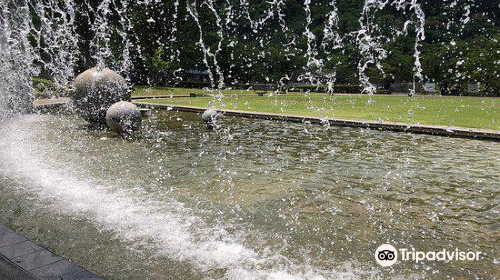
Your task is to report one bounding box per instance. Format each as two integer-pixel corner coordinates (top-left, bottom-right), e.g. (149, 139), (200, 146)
(65, 0), (500, 94)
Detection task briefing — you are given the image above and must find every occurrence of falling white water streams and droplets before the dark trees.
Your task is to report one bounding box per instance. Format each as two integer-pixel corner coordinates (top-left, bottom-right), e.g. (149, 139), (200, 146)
(2, 0), (492, 110)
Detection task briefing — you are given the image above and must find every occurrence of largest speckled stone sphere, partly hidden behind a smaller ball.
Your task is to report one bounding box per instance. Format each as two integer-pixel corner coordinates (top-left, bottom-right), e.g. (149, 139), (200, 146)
(71, 68), (130, 124)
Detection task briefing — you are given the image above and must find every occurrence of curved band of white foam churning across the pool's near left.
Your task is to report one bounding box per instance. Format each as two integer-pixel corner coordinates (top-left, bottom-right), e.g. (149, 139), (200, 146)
(0, 116), (376, 280)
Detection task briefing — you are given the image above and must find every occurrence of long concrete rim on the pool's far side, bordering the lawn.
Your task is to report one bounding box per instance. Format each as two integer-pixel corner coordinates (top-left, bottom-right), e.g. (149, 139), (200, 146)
(134, 101), (500, 141)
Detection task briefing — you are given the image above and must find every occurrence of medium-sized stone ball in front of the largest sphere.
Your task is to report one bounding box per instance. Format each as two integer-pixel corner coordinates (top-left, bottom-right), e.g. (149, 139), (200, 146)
(106, 101), (142, 134)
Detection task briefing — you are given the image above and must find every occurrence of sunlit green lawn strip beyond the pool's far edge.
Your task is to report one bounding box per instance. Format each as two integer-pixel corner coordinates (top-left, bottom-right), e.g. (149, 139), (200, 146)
(137, 89), (500, 130)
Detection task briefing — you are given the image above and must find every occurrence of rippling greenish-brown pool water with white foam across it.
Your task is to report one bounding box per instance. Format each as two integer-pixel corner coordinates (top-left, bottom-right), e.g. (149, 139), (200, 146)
(0, 111), (500, 279)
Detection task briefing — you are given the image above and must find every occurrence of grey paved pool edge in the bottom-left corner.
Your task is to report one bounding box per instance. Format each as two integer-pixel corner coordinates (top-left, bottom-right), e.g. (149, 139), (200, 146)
(0, 221), (102, 280)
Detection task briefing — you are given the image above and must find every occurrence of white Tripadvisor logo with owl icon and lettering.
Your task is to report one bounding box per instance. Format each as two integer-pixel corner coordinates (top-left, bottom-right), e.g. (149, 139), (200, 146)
(375, 244), (481, 266)
